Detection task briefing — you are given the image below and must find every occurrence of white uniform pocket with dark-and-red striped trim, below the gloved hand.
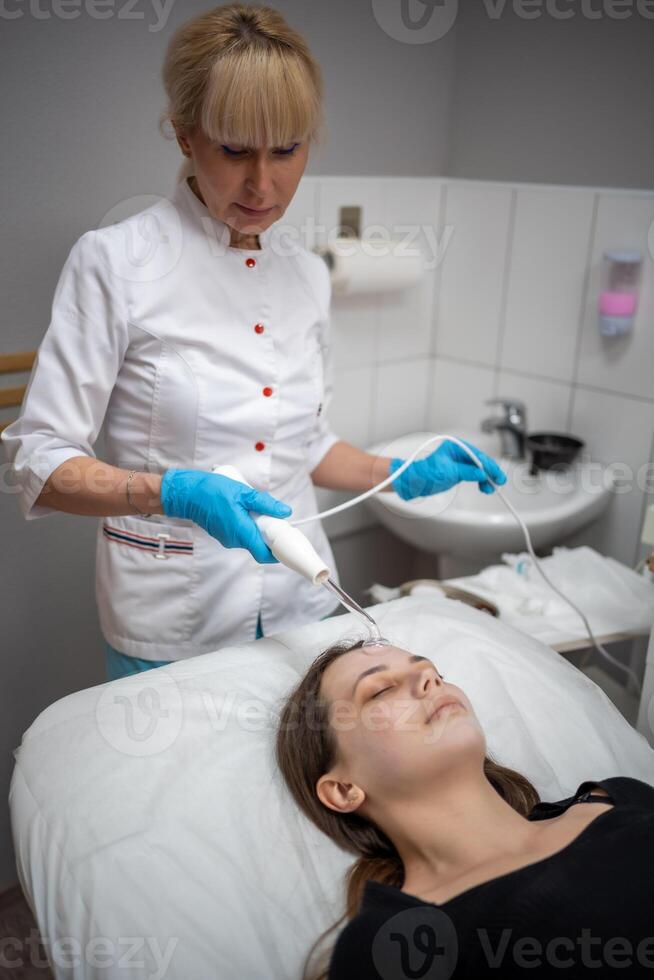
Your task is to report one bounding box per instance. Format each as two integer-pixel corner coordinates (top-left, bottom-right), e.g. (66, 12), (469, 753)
(96, 516), (195, 645)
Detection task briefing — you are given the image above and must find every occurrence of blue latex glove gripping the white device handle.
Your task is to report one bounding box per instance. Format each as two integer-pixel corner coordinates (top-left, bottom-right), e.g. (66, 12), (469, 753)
(161, 470), (292, 564)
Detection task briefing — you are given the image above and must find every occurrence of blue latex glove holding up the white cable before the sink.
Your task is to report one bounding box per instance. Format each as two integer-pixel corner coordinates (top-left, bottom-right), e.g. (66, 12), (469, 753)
(389, 439), (506, 500)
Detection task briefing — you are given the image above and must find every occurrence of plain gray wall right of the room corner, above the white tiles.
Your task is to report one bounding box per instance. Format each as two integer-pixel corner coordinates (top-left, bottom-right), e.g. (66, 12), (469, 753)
(452, 0), (654, 188)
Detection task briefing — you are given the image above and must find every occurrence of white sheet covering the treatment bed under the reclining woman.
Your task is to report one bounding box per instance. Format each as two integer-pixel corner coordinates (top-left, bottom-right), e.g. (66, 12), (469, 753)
(10, 596), (654, 980)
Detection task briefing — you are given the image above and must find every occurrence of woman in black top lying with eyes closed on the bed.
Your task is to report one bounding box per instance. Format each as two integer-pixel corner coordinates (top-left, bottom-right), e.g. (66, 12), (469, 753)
(276, 642), (654, 980)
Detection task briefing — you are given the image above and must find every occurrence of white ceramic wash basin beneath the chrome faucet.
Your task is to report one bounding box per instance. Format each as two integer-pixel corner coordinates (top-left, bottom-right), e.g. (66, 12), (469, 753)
(366, 432), (613, 555)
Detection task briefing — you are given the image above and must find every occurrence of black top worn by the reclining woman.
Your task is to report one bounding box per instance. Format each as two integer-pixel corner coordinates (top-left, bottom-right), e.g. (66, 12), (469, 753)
(329, 776), (654, 980)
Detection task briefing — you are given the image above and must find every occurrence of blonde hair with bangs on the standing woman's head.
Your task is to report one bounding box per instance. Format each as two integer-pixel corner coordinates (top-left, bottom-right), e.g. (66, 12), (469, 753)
(159, 3), (324, 181)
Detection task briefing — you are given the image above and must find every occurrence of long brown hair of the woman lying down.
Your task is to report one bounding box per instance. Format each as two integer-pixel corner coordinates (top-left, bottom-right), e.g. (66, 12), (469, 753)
(275, 640), (540, 980)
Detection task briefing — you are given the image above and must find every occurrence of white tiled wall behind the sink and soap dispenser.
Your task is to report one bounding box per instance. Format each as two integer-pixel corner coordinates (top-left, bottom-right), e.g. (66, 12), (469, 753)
(284, 177), (654, 563)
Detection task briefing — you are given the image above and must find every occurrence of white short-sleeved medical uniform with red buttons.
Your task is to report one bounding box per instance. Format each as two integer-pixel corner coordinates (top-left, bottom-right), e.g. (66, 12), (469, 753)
(3, 180), (338, 660)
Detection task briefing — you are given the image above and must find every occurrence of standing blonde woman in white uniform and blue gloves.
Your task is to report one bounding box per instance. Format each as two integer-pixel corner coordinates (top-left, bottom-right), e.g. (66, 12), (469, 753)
(3, 4), (505, 678)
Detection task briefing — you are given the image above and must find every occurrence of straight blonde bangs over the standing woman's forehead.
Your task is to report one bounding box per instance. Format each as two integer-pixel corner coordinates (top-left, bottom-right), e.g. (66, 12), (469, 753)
(200, 46), (322, 149)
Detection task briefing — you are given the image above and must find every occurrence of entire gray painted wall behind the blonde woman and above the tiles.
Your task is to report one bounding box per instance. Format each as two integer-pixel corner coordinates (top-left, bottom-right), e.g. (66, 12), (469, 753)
(0, 0), (654, 888)
